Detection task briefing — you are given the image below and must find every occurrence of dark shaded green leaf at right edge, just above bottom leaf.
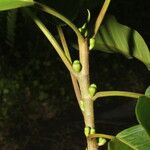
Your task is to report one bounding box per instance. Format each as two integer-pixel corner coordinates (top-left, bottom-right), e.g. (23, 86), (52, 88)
(136, 96), (150, 136)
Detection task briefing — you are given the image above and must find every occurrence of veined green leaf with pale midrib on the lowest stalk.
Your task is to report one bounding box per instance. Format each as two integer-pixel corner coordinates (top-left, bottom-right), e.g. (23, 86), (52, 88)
(108, 125), (150, 150)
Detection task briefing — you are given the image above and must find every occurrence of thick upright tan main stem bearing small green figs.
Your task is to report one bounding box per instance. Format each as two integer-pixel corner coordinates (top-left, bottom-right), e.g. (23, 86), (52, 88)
(78, 39), (98, 150)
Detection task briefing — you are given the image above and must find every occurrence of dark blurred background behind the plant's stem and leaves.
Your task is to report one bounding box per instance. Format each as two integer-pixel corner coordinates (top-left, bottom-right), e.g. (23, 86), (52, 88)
(0, 0), (150, 150)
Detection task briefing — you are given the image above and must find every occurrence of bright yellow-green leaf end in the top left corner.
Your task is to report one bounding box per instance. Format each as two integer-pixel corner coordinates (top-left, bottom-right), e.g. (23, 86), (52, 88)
(0, 0), (34, 11)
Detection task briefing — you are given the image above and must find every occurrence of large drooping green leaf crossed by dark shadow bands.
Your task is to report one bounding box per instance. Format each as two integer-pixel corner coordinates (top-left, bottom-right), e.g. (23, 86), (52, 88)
(94, 16), (150, 70)
